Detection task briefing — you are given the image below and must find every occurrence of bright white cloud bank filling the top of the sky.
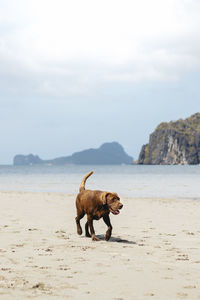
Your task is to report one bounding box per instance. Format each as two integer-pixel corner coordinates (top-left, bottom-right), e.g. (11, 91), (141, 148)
(0, 0), (200, 97)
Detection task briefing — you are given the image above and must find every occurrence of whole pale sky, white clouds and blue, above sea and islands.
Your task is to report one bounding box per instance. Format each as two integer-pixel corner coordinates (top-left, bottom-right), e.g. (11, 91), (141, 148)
(0, 0), (200, 164)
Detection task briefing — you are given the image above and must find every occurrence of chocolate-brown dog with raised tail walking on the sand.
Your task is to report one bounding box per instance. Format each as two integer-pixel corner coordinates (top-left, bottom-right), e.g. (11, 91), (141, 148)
(75, 171), (123, 241)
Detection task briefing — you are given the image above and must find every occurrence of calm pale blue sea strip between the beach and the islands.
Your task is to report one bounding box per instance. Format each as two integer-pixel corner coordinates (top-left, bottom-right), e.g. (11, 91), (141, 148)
(0, 165), (200, 200)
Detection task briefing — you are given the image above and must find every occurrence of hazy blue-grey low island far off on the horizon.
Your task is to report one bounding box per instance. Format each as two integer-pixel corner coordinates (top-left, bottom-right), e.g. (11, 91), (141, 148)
(13, 142), (133, 166)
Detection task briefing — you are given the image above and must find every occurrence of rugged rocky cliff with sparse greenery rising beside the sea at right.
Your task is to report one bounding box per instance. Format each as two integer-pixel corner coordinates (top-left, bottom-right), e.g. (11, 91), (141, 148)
(136, 113), (200, 165)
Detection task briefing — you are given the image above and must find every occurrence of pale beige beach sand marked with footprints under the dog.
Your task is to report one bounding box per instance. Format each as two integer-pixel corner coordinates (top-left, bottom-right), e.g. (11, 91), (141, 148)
(0, 192), (200, 300)
